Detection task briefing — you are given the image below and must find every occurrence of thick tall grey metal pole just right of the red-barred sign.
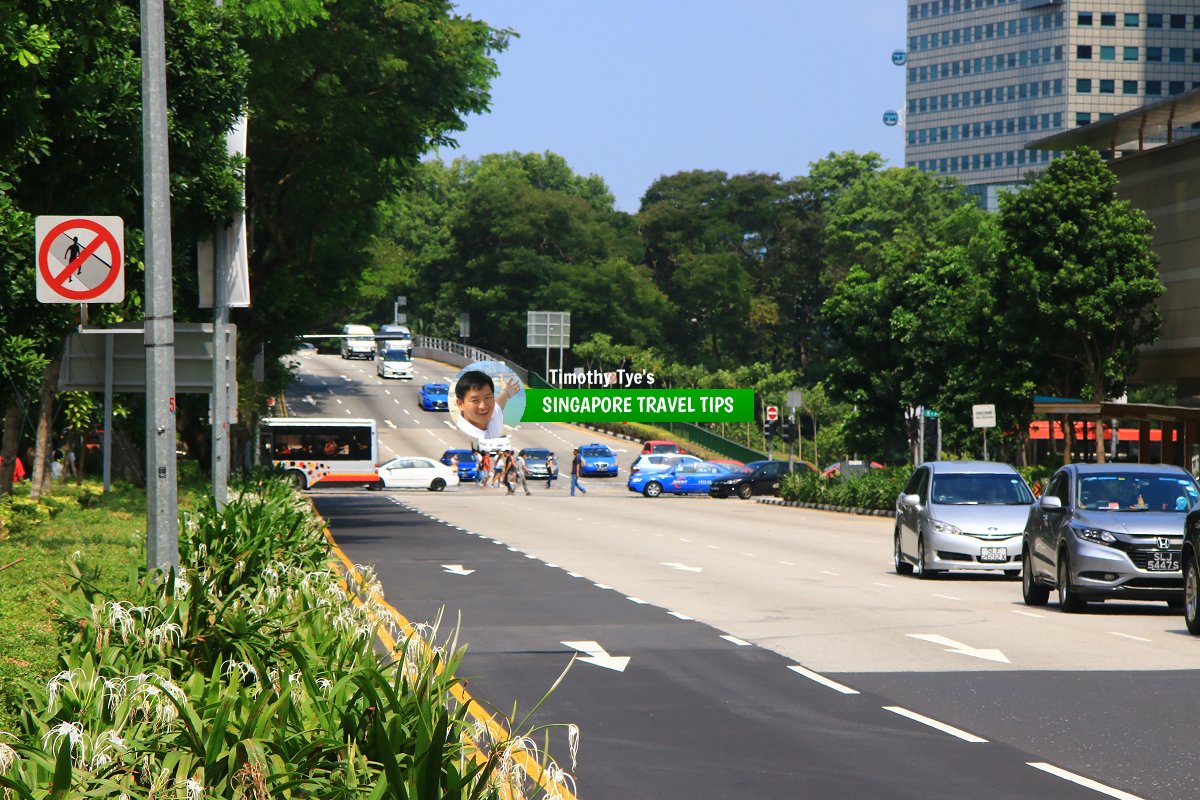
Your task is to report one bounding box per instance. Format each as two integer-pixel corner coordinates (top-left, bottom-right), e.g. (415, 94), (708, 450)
(142, 0), (179, 571)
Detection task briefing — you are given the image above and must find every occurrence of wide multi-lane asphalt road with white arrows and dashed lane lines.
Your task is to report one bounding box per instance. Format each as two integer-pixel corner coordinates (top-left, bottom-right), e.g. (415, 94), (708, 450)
(288, 356), (1200, 800)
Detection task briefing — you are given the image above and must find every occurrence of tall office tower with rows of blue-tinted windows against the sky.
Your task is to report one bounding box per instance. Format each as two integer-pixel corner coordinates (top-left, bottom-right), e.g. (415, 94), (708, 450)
(904, 0), (1200, 207)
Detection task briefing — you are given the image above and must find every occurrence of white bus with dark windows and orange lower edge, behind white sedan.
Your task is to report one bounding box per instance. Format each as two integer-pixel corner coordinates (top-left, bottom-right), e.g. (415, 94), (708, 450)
(259, 416), (379, 489)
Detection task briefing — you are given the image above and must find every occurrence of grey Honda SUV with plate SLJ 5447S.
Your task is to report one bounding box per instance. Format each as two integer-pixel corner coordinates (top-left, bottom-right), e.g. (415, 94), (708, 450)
(1022, 464), (1200, 612)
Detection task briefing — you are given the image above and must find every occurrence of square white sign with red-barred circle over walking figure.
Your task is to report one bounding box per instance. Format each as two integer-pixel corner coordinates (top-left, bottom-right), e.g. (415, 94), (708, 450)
(34, 216), (125, 302)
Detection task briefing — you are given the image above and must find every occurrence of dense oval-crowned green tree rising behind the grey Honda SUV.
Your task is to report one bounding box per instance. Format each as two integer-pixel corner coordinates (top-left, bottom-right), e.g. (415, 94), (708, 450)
(1000, 150), (1164, 462)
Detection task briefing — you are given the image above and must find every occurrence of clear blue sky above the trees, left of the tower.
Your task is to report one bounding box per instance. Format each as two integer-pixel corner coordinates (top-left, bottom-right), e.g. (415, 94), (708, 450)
(439, 0), (906, 212)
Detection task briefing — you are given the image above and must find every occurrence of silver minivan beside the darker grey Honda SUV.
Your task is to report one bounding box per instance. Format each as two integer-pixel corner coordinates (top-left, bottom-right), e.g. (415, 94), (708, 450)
(893, 461), (1033, 578)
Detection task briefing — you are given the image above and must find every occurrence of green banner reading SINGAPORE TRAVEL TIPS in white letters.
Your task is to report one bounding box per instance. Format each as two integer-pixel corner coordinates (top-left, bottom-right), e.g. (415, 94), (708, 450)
(521, 389), (754, 422)
